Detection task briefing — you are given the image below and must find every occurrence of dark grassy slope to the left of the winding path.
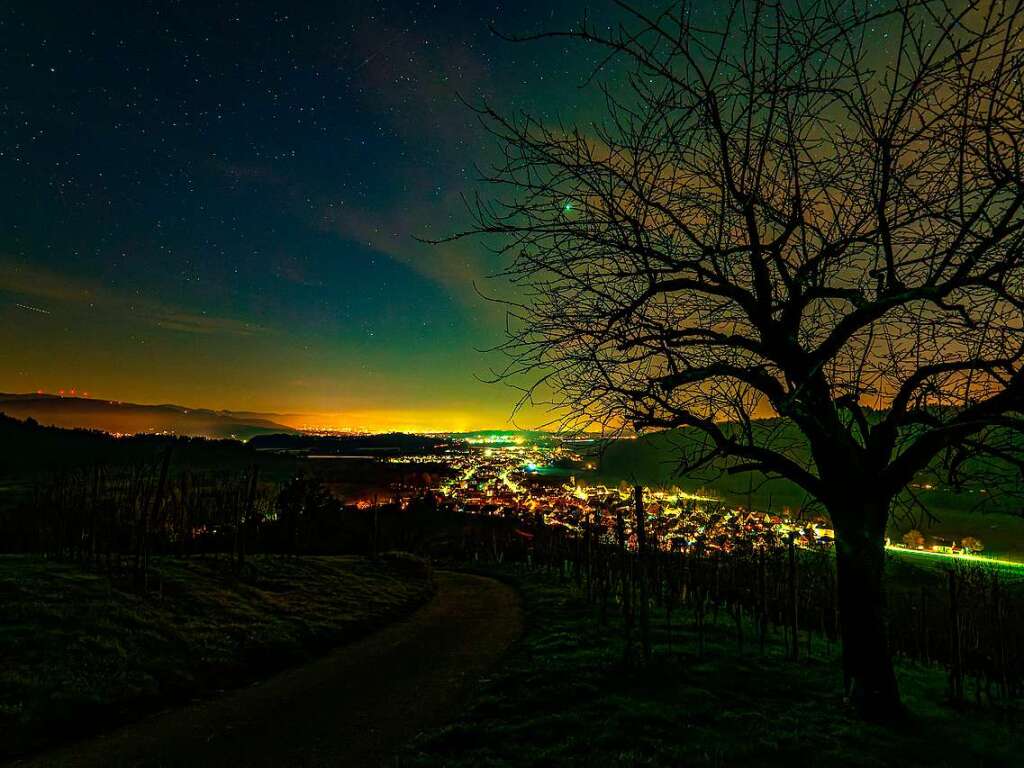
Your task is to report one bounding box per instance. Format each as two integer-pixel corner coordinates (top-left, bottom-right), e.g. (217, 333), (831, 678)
(0, 556), (433, 756)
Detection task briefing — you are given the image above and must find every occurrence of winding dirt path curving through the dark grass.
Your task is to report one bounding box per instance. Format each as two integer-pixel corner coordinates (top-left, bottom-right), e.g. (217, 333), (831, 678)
(15, 572), (522, 767)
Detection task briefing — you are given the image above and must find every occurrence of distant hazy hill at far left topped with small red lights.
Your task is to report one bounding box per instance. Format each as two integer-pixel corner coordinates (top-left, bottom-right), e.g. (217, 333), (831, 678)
(0, 393), (296, 440)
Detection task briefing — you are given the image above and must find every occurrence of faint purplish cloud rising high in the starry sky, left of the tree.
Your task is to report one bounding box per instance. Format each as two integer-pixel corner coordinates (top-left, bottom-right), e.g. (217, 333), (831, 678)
(314, 16), (512, 307)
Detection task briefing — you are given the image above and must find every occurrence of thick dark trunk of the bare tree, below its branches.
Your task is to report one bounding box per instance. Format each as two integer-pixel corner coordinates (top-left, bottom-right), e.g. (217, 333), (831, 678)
(836, 523), (903, 722)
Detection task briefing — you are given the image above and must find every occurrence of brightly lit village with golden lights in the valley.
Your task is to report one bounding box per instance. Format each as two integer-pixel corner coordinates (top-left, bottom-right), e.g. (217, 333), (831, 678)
(385, 434), (999, 564)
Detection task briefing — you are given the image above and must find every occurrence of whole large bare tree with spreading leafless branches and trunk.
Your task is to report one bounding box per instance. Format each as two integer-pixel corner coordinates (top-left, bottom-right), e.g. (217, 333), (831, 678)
(456, 0), (1024, 719)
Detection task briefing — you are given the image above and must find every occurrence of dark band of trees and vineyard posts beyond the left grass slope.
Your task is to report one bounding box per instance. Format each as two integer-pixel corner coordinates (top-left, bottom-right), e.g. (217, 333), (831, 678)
(0, 441), (509, 585)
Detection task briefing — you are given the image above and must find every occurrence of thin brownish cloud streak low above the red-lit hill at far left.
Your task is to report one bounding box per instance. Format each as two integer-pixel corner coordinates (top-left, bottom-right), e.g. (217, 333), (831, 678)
(0, 256), (266, 336)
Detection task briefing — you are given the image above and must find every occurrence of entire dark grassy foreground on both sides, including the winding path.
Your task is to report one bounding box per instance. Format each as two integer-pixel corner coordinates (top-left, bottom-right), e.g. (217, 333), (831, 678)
(6, 557), (1024, 768)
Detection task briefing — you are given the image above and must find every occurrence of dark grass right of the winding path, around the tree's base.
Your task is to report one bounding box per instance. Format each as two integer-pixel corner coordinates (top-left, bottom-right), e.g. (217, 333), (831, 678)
(401, 574), (1024, 768)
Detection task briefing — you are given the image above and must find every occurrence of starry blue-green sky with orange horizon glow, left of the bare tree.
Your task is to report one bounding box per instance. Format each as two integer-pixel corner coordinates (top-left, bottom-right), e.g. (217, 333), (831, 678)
(0, 0), (638, 429)
